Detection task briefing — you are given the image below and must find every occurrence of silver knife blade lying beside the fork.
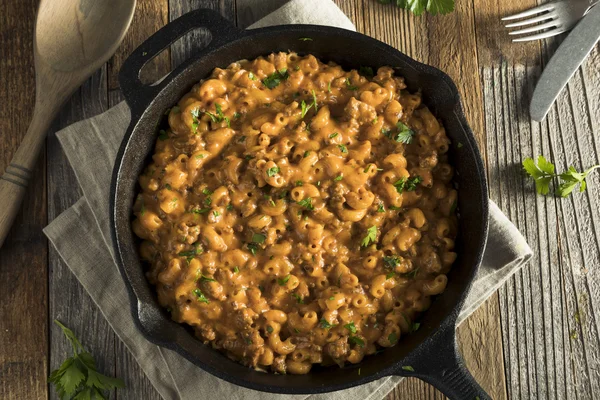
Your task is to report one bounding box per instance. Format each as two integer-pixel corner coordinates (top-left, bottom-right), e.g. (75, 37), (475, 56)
(529, 7), (600, 121)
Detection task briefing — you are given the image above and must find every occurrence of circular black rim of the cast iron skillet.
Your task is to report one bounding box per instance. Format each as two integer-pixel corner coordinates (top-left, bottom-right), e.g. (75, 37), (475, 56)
(110, 20), (489, 394)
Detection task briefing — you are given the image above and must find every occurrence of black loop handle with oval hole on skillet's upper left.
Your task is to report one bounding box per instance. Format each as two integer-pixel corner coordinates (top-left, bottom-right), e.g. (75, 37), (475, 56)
(119, 9), (244, 116)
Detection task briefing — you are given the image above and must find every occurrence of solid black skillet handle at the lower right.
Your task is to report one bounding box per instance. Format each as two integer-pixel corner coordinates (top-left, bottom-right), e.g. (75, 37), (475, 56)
(396, 325), (491, 400)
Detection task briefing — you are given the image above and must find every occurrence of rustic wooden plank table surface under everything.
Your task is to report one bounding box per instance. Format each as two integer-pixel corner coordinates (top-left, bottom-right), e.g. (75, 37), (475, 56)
(0, 0), (600, 400)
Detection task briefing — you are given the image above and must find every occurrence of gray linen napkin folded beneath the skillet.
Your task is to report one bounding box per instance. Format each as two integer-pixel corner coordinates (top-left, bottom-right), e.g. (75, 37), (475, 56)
(44, 0), (532, 400)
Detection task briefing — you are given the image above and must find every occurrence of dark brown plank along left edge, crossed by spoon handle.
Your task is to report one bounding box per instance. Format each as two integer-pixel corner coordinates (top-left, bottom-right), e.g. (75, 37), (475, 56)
(0, 0), (48, 400)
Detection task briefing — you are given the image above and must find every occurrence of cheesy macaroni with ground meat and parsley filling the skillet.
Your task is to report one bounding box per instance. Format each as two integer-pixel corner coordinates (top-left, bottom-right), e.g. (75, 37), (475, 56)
(132, 53), (458, 374)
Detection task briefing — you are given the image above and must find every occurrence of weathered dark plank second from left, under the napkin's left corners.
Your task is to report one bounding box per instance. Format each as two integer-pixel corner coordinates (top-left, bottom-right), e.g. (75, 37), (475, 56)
(47, 67), (115, 399)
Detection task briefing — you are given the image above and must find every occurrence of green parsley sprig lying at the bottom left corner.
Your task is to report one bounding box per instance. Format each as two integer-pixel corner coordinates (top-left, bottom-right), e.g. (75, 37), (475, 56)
(48, 320), (125, 400)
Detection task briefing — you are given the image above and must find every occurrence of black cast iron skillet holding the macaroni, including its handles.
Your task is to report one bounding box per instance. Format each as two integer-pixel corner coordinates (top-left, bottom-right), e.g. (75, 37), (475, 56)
(110, 10), (489, 400)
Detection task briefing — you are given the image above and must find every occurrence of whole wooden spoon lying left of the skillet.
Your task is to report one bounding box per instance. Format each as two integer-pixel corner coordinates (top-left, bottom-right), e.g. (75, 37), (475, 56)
(0, 0), (136, 247)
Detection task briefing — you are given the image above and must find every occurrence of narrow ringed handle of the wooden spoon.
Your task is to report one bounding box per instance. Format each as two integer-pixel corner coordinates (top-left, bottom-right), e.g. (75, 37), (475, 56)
(0, 107), (58, 247)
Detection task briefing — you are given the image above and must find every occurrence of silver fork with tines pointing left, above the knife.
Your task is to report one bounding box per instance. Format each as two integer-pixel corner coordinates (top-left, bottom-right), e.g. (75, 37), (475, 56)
(502, 0), (598, 42)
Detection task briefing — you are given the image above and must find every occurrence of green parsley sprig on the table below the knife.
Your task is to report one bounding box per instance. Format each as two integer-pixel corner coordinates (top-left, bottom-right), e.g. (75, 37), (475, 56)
(523, 156), (600, 197)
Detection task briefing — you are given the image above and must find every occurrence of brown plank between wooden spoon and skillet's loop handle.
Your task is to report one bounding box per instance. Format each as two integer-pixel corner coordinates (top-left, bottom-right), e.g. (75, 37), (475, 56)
(108, 0), (170, 90)
